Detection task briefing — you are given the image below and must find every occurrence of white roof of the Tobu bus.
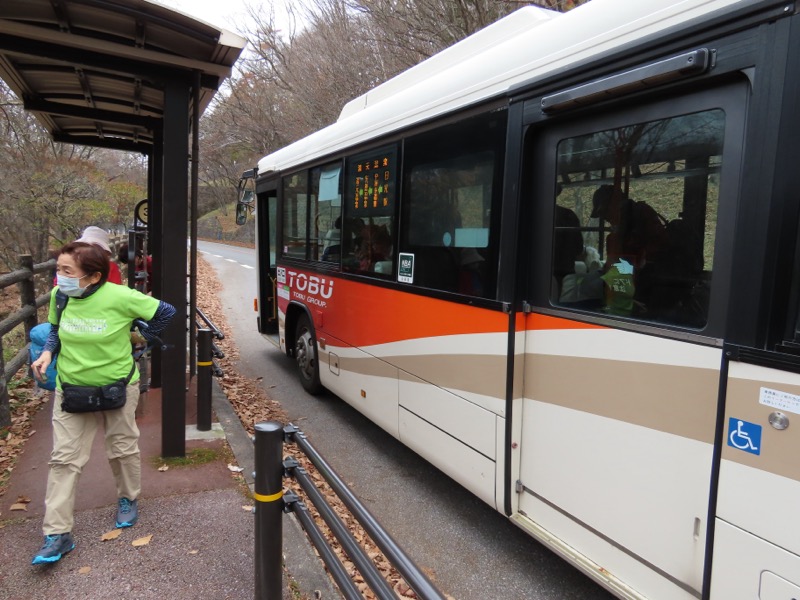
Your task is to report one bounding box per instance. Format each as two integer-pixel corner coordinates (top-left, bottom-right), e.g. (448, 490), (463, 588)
(258, 0), (759, 174)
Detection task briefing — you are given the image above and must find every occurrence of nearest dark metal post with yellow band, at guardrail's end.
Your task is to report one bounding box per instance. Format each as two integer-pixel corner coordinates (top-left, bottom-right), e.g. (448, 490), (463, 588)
(253, 421), (283, 600)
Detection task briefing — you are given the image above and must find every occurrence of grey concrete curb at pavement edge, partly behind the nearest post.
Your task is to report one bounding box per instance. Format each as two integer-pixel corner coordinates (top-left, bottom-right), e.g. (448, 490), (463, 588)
(211, 380), (342, 598)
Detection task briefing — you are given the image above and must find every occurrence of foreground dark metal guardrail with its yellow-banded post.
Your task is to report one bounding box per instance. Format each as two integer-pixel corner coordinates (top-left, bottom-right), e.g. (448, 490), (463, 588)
(253, 421), (444, 600)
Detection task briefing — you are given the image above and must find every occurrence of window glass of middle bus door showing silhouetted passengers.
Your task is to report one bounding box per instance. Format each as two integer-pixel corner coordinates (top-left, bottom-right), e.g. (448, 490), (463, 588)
(551, 110), (725, 329)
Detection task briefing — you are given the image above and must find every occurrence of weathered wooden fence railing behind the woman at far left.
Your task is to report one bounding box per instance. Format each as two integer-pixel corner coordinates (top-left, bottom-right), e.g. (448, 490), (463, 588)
(0, 236), (126, 428)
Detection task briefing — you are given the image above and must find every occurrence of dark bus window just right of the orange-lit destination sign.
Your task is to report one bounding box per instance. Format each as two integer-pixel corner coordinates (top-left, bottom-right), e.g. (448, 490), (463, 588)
(402, 112), (505, 297)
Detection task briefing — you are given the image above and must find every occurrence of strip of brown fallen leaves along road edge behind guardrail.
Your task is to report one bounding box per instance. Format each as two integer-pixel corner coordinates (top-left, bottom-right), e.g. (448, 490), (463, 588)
(197, 257), (424, 600)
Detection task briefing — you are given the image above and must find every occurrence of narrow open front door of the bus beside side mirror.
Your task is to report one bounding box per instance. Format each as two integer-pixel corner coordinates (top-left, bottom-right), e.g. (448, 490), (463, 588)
(256, 179), (280, 347)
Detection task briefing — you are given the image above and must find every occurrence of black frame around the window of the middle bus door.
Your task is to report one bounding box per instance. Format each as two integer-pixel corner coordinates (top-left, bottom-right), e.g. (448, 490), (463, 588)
(521, 77), (750, 345)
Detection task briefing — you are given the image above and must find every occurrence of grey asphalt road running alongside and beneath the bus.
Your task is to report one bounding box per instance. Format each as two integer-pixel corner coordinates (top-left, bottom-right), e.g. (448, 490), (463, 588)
(198, 242), (612, 600)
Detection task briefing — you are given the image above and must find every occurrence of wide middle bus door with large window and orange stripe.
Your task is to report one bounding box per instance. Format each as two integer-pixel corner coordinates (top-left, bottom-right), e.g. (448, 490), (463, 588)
(512, 82), (748, 599)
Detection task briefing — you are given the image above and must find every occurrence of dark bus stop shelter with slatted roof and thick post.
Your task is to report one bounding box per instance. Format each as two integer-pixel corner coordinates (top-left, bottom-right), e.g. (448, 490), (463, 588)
(0, 0), (245, 456)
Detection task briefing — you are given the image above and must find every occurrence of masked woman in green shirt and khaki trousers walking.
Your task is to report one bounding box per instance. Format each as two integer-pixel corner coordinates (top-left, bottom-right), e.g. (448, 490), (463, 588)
(31, 242), (175, 565)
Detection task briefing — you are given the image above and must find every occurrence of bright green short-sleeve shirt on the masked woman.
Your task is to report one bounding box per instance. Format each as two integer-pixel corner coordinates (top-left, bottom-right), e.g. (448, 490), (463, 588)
(48, 283), (159, 389)
